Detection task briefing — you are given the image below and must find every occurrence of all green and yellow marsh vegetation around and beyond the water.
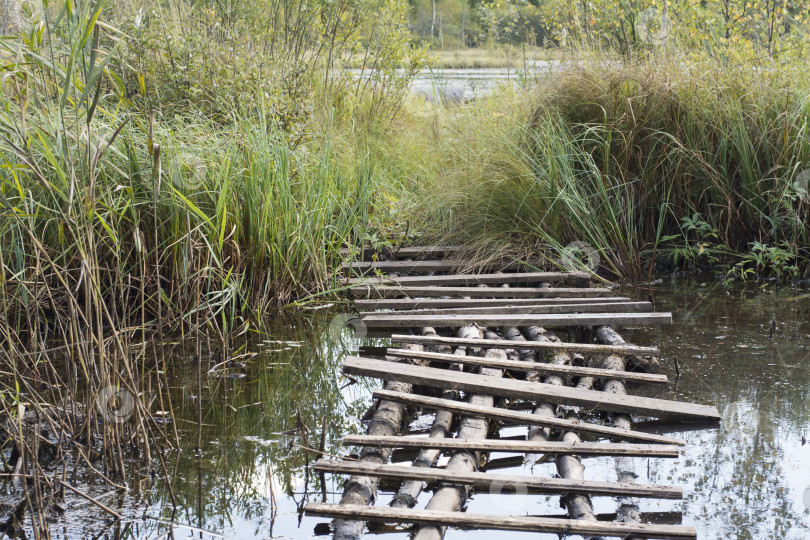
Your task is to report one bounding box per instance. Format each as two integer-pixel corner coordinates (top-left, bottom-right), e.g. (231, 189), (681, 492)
(0, 0), (810, 538)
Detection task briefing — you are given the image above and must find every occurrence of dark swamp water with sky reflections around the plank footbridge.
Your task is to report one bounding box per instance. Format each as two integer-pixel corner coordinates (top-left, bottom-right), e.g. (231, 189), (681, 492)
(9, 279), (810, 539)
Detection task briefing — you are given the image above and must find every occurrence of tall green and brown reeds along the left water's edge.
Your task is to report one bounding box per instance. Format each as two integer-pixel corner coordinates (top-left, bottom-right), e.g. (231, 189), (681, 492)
(0, 2), (382, 538)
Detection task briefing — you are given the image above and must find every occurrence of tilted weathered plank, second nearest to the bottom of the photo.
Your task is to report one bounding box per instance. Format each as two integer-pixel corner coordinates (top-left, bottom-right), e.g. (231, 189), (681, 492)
(315, 459), (683, 499)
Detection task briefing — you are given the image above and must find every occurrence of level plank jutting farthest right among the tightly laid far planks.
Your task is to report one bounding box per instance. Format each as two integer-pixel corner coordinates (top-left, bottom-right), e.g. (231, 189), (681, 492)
(362, 312), (672, 328)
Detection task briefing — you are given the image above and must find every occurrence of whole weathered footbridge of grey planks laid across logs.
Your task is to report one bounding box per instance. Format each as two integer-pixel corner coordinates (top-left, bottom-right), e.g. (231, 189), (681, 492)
(305, 246), (719, 540)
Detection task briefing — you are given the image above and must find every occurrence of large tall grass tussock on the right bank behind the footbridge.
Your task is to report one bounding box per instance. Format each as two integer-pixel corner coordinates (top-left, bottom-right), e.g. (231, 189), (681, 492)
(416, 58), (810, 278)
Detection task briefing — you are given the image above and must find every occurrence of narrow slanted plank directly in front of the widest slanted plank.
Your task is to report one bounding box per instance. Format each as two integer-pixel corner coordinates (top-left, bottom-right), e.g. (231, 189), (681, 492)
(373, 390), (686, 446)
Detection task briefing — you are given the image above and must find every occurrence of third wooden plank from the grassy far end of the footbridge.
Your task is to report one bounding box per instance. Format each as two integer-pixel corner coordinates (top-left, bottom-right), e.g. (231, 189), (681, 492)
(347, 272), (591, 287)
